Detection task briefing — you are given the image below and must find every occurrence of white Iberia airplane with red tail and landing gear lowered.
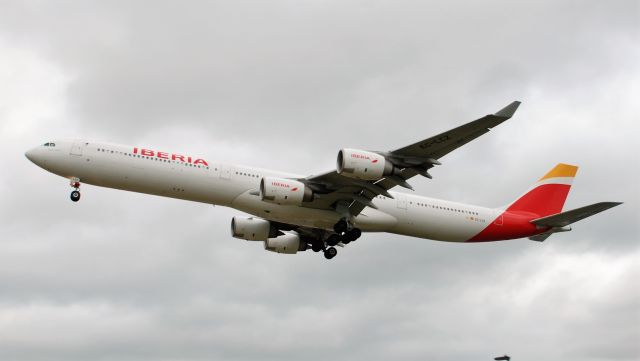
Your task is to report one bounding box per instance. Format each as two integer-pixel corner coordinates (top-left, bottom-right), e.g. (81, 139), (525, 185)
(25, 101), (621, 259)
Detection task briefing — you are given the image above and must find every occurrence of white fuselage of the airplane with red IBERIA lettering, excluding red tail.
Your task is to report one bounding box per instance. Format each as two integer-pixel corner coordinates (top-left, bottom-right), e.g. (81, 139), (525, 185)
(27, 141), (501, 242)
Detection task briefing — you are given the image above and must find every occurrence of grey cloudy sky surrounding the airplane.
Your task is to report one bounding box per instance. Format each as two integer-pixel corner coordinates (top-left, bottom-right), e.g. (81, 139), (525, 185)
(0, 0), (640, 360)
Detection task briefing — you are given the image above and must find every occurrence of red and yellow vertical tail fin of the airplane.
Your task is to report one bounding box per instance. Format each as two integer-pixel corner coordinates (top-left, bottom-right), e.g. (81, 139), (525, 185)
(507, 163), (578, 217)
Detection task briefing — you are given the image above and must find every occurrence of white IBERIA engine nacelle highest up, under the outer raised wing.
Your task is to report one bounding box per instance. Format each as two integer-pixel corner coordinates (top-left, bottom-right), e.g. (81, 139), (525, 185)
(338, 148), (394, 180)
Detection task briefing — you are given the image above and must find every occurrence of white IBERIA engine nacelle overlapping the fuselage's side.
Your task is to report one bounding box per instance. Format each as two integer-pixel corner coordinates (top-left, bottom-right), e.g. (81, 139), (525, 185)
(260, 177), (313, 206)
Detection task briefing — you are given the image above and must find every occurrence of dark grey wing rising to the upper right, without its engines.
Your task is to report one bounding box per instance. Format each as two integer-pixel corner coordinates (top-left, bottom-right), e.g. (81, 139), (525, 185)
(298, 101), (520, 216)
